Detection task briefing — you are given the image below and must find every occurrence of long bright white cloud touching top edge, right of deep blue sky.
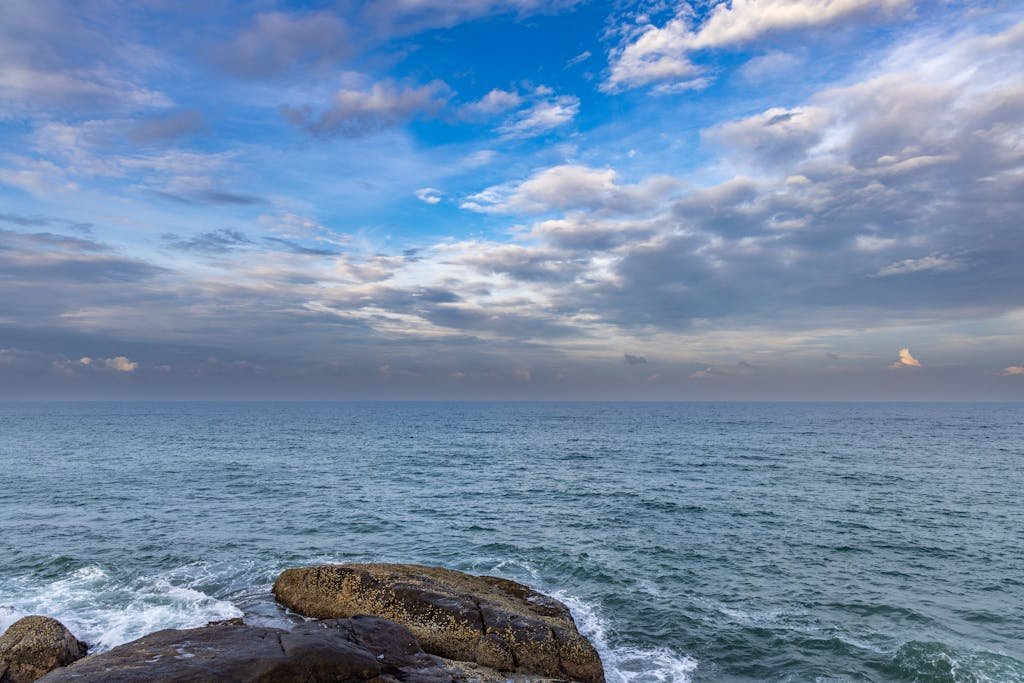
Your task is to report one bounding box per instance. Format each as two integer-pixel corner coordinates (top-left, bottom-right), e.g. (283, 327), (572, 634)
(601, 0), (910, 92)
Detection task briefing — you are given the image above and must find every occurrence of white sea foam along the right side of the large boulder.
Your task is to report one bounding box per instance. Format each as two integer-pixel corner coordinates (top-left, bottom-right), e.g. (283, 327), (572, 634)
(552, 591), (697, 683)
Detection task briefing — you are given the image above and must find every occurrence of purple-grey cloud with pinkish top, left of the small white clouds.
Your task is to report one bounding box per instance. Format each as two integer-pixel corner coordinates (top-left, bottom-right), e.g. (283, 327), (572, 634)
(282, 80), (450, 137)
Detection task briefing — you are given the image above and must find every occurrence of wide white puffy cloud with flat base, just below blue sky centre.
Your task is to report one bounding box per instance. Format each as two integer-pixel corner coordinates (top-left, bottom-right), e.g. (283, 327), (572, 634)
(461, 164), (679, 213)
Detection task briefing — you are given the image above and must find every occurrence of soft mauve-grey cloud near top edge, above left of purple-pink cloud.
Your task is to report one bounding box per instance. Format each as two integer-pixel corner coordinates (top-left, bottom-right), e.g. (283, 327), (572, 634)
(214, 11), (352, 79)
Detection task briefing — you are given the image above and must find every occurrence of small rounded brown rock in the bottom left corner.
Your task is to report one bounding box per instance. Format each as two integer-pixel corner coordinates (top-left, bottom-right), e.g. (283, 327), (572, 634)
(0, 616), (88, 683)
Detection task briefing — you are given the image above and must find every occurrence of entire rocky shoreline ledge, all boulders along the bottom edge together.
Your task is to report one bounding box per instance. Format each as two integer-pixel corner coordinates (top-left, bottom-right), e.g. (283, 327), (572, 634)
(14, 564), (604, 683)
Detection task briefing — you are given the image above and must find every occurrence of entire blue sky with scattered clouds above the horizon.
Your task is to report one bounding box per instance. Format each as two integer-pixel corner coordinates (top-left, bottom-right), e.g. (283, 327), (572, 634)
(0, 0), (1024, 400)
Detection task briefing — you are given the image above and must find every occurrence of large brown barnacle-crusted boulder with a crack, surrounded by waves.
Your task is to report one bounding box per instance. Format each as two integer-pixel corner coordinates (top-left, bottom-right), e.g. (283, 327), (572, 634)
(273, 564), (604, 683)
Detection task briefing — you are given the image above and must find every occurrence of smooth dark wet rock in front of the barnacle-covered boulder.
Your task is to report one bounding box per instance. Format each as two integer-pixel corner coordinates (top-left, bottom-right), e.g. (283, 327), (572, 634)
(40, 616), (565, 683)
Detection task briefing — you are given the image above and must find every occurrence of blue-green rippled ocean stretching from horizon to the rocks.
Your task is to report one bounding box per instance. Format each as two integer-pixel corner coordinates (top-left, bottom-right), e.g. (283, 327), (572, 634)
(0, 402), (1024, 683)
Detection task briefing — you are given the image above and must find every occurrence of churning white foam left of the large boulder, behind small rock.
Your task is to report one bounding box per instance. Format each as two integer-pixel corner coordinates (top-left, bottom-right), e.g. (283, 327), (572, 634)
(0, 566), (242, 651)
